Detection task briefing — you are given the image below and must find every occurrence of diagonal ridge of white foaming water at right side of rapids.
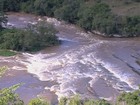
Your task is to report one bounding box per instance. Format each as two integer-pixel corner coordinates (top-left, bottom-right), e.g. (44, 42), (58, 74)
(94, 53), (140, 89)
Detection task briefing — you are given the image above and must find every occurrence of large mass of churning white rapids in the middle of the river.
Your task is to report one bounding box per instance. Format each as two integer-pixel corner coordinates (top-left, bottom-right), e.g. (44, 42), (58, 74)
(18, 39), (140, 98)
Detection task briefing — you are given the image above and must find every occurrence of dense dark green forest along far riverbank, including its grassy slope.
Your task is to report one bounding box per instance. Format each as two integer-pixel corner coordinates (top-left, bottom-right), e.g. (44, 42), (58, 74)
(1, 0), (140, 37)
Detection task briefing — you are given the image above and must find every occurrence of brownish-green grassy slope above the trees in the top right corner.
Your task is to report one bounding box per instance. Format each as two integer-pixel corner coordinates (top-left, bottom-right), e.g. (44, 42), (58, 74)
(102, 0), (140, 16)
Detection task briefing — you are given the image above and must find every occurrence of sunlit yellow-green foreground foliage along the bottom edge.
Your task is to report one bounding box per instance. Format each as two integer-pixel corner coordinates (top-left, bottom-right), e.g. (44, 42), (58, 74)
(0, 84), (140, 105)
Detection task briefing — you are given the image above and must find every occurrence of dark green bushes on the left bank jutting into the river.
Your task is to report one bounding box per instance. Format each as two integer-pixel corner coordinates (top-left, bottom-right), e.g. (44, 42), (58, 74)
(0, 3), (59, 53)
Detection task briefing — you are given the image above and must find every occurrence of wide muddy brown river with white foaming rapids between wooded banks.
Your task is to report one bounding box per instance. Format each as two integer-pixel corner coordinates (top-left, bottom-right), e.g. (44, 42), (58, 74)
(0, 13), (140, 104)
